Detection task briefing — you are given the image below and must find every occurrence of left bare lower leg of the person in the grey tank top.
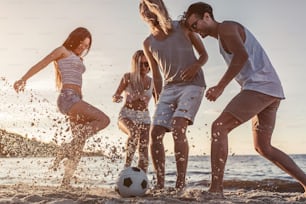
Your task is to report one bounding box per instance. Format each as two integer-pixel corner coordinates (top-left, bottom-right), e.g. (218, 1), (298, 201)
(150, 125), (166, 189)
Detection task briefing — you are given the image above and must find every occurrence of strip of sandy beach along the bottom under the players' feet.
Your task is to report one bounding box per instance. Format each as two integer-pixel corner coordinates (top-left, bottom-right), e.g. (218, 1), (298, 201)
(0, 184), (306, 204)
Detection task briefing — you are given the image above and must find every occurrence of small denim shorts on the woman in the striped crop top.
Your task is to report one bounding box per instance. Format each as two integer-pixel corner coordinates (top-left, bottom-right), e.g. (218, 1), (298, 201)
(57, 89), (82, 115)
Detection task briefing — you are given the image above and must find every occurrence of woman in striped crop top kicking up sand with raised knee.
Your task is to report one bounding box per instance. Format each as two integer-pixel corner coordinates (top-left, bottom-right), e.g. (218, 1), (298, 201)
(14, 27), (110, 187)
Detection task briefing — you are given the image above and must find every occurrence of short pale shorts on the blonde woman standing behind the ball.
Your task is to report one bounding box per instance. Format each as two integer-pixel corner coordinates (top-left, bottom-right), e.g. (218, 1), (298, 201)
(119, 107), (151, 124)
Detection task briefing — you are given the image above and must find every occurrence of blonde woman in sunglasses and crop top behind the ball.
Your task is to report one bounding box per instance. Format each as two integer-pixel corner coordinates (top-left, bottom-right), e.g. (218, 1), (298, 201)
(113, 50), (153, 172)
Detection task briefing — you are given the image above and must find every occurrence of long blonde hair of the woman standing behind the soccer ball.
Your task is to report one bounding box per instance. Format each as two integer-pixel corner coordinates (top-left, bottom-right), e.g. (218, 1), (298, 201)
(130, 50), (145, 94)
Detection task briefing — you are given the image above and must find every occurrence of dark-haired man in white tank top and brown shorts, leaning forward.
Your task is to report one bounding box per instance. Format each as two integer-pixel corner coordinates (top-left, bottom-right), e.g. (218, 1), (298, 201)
(184, 2), (306, 195)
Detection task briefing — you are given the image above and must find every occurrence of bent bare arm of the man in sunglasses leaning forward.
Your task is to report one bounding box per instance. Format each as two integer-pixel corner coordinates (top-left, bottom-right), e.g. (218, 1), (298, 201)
(206, 22), (248, 101)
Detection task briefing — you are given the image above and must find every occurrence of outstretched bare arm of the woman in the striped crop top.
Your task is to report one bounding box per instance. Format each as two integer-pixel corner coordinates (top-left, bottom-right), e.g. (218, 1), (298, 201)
(14, 47), (65, 92)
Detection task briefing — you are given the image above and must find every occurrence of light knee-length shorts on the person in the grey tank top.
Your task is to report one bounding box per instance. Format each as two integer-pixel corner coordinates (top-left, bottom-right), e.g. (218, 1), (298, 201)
(153, 84), (205, 130)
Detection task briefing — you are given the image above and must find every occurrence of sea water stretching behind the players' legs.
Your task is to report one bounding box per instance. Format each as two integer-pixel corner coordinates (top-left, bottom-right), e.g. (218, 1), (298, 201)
(0, 155), (306, 192)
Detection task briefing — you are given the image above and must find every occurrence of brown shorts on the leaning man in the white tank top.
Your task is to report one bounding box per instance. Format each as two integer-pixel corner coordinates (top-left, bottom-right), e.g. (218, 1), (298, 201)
(223, 90), (281, 133)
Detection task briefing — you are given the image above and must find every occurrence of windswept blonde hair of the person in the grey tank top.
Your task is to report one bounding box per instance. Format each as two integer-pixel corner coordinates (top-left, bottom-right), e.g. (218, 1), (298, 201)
(139, 0), (172, 35)
